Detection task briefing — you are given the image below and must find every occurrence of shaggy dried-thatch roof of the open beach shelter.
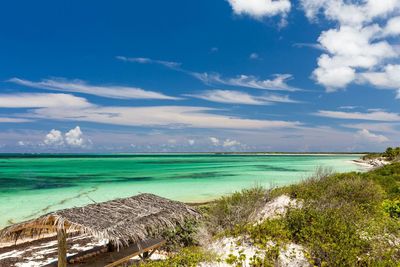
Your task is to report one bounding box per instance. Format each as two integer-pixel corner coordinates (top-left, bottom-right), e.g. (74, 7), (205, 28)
(0, 194), (199, 245)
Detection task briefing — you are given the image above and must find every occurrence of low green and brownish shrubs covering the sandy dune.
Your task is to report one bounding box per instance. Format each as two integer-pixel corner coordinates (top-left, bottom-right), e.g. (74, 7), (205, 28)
(143, 163), (400, 266)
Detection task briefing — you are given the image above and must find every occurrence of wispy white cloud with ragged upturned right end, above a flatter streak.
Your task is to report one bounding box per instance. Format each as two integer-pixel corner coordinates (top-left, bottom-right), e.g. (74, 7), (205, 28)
(190, 72), (300, 92)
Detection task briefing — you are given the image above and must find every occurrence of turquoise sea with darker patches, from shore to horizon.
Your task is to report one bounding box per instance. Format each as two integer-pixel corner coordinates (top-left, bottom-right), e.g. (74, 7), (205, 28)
(0, 154), (362, 227)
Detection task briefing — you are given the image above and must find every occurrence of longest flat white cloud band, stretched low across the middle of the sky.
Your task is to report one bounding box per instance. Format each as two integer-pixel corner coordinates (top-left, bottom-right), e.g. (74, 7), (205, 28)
(21, 102), (300, 129)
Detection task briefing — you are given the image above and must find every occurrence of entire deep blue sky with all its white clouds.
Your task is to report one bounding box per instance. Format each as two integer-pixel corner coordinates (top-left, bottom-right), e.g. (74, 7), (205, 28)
(0, 0), (400, 153)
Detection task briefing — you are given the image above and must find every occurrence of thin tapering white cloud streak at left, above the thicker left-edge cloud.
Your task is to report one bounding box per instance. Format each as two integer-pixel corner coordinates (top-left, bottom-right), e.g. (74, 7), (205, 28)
(8, 78), (180, 100)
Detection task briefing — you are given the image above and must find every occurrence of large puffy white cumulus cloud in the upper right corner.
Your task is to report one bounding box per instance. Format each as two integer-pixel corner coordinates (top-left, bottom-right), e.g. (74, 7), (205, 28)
(301, 0), (400, 91)
